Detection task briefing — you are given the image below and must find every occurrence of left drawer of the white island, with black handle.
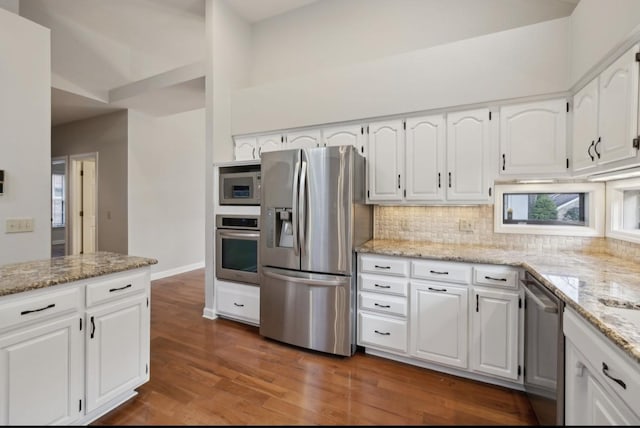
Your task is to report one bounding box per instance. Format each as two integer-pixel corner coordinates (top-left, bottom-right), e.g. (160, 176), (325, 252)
(0, 286), (82, 330)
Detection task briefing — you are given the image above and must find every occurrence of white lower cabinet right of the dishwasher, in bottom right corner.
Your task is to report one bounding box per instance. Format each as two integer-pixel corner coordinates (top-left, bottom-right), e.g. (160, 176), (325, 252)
(563, 307), (640, 426)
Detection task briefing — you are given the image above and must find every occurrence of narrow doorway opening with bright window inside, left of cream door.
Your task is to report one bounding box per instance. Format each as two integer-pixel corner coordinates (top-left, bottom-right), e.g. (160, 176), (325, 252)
(51, 156), (69, 257)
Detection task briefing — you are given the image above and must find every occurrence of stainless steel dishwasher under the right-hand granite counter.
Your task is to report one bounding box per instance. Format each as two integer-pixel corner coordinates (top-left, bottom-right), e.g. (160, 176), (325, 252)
(522, 272), (564, 425)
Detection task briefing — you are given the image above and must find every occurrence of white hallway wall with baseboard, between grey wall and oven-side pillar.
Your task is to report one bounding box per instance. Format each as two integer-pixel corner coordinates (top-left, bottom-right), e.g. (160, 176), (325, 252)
(128, 109), (205, 279)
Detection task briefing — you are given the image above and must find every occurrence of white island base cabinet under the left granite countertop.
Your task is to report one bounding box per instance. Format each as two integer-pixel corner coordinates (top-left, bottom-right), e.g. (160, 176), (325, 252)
(0, 268), (150, 425)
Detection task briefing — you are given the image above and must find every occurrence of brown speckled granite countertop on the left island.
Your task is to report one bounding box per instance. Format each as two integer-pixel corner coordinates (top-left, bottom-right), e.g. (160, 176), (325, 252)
(0, 251), (158, 297)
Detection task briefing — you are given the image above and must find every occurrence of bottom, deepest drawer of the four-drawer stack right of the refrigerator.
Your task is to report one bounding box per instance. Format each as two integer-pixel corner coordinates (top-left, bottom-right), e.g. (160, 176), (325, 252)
(358, 312), (407, 353)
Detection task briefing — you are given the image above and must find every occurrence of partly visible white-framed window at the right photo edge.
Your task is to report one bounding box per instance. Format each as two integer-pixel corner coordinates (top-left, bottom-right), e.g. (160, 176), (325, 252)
(607, 178), (640, 242)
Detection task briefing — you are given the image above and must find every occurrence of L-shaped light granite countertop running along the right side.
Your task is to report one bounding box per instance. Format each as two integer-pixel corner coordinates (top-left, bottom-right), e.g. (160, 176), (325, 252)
(356, 239), (640, 363)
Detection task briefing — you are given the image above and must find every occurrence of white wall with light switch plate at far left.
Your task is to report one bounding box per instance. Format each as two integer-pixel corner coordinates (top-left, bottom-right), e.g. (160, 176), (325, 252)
(0, 9), (51, 265)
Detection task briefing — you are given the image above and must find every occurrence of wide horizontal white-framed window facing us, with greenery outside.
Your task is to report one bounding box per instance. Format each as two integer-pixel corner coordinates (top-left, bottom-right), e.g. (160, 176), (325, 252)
(494, 183), (604, 236)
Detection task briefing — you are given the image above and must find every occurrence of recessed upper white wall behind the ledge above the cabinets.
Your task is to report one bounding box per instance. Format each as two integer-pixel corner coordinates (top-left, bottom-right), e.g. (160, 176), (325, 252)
(251, 0), (574, 85)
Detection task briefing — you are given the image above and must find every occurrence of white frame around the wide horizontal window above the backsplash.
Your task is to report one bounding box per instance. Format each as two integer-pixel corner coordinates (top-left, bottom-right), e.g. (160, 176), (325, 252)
(493, 182), (605, 237)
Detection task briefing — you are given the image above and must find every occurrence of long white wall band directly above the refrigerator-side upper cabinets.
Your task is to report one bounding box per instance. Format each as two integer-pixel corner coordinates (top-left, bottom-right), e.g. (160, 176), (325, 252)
(232, 18), (569, 135)
